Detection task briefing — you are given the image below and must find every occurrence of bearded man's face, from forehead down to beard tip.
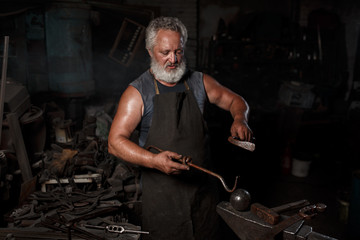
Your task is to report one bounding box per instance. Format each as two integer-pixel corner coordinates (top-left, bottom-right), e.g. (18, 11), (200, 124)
(149, 30), (186, 83)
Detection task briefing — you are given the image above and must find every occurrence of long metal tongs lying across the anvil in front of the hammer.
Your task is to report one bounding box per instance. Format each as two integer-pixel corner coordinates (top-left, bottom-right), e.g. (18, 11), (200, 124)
(257, 203), (326, 240)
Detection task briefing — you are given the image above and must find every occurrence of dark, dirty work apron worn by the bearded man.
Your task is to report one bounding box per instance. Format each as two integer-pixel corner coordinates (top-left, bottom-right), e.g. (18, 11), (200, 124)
(142, 80), (219, 240)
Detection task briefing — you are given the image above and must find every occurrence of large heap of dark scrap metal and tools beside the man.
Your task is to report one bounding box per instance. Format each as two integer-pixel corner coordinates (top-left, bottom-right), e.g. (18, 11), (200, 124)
(0, 138), (147, 239)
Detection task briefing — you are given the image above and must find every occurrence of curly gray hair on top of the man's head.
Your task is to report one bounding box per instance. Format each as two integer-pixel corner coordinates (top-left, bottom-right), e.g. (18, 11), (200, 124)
(145, 17), (188, 50)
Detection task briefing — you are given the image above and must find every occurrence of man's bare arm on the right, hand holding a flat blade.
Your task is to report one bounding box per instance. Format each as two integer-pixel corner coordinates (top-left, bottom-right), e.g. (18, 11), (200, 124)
(204, 74), (252, 141)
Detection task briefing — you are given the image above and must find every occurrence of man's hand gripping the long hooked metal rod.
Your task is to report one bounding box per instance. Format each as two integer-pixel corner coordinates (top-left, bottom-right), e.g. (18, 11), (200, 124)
(152, 151), (189, 175)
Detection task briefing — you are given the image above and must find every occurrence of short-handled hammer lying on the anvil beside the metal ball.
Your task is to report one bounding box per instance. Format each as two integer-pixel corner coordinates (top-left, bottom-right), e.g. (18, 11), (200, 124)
(250, 200), (310, 225)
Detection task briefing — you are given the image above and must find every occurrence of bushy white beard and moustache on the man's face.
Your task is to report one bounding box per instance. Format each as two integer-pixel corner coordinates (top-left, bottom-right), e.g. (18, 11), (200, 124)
(150, 58), (186, 83)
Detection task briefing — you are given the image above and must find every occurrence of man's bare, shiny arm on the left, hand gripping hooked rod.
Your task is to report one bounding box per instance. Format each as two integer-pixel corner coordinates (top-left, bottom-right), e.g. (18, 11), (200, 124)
(108, 86), (188, 174)
